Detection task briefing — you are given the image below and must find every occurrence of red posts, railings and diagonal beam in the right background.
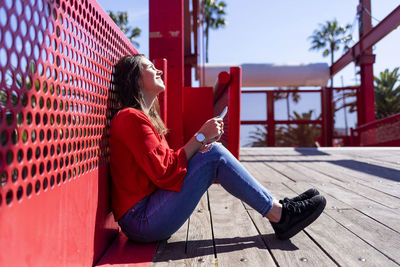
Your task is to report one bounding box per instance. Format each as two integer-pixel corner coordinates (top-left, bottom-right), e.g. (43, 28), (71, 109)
(242, 0), (400, 146)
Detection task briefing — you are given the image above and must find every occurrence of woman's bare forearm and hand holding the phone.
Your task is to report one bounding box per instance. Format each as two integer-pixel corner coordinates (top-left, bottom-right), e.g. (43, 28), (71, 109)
(183, 117), (224, 160)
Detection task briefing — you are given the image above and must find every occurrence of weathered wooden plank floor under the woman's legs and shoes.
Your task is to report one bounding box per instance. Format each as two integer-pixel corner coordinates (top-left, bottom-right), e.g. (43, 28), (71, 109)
(153, 148), (400, 267)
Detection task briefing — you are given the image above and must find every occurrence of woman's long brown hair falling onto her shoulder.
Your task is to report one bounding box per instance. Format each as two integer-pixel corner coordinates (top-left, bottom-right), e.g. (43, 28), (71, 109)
(114, 54), (168, 135)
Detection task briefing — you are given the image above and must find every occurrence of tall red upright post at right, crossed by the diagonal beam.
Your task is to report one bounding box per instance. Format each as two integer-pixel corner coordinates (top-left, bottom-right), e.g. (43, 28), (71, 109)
(356, 0), (375, 125)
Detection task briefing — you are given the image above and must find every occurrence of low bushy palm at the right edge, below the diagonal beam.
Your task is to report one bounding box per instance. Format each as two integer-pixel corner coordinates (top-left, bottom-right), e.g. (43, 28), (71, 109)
(374, 67), (400, 119)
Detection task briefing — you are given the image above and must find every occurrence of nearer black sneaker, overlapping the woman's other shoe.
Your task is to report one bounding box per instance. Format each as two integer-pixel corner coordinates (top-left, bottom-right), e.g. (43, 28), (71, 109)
(271, 195), (326, 240)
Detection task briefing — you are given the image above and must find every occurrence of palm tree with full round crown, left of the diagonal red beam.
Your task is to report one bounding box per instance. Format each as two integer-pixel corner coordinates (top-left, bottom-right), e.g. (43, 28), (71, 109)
(309, 19), (352, 87)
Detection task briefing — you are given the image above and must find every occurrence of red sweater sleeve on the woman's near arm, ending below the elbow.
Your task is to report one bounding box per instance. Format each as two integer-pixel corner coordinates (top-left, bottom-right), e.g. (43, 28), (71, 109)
(113, 110), (187, 191)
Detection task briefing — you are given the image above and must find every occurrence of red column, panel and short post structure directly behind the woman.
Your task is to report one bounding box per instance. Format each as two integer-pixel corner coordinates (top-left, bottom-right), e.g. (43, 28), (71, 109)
(149, 0), (241, 157)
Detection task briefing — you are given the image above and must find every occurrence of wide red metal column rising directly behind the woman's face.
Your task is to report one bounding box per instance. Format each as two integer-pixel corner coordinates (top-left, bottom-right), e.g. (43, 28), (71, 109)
(149, 0), (184, 148)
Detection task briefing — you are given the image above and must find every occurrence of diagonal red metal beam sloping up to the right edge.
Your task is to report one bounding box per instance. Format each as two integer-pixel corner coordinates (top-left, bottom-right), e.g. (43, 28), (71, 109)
(330, 5), (400, 76)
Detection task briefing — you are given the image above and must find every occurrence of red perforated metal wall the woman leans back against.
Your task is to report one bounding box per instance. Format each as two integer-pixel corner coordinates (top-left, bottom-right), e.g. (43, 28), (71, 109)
(0, 0), (137, 266)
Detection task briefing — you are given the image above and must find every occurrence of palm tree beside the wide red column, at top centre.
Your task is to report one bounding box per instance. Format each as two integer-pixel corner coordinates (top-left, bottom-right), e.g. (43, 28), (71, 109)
(203, 0), (226, 62)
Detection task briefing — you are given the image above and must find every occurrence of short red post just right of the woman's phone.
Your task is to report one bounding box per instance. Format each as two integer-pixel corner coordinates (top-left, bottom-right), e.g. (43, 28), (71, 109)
(228, 67), (242, 159)
